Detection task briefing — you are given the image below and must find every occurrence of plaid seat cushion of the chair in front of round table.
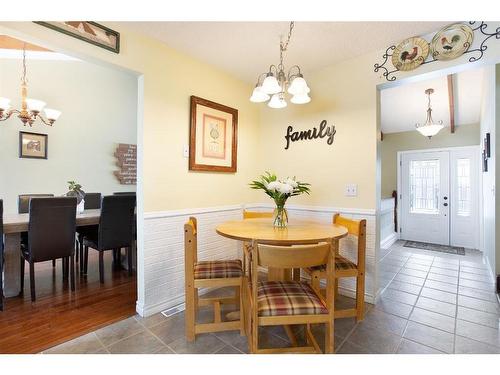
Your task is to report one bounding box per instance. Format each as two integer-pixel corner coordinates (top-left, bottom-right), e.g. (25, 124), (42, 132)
(257, 281), (328, 316)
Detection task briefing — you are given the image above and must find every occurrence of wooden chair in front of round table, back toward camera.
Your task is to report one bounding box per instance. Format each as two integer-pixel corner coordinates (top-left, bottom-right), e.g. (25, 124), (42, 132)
(245, 241), (338, 353)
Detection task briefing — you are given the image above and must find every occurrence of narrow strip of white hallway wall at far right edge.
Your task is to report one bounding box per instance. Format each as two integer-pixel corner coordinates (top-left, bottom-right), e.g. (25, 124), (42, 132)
(480, 65), (496, 272)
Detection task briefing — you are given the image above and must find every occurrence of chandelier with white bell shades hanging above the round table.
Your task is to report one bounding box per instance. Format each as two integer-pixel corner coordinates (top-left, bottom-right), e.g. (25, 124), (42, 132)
(250, 22), (311, 108)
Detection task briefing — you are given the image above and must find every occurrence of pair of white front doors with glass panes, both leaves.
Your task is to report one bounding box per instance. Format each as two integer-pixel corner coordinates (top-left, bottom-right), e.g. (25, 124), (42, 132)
(398, 146), (480, 249)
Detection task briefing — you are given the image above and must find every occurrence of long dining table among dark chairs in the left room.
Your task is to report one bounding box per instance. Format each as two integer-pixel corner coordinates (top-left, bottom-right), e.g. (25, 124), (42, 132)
(3, 210), (101, 297)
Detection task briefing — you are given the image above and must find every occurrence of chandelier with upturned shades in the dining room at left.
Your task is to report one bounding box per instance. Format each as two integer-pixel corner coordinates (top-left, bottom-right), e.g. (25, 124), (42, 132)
(0, 44), (61, 126)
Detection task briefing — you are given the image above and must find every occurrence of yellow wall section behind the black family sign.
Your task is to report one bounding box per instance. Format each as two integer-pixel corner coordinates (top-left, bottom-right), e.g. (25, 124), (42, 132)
(260, 56), (377, 209)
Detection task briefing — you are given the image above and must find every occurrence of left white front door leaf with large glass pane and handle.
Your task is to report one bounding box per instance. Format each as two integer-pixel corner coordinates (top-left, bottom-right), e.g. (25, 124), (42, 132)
(400, 151), (450, 245)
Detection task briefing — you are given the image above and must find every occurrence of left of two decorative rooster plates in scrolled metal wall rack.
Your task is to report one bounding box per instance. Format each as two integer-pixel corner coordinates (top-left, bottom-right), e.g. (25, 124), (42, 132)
(392, 36), (429, 71)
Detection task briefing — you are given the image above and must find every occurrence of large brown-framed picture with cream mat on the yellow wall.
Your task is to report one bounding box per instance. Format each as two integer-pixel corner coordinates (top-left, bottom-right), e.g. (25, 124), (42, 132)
(189, 96), (238, 173)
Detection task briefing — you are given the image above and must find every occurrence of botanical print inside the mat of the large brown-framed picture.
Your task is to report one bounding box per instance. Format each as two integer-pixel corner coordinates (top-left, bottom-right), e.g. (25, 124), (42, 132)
(202, 113), (226, 159)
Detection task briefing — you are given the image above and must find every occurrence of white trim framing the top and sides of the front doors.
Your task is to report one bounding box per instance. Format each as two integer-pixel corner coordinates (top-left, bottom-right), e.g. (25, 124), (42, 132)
(396, 145), (483, 251)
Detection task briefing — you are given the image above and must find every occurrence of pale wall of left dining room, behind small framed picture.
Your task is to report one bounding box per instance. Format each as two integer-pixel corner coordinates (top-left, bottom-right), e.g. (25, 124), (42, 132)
(0, 59), (137, 214)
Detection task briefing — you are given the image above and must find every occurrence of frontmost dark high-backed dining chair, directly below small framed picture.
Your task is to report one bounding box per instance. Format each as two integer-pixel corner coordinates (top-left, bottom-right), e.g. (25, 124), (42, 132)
(21, 197), (77, 302)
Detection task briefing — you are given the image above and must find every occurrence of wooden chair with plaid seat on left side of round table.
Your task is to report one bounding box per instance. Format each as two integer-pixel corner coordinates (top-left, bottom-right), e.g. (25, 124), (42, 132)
(184, 217), (245, 341)
